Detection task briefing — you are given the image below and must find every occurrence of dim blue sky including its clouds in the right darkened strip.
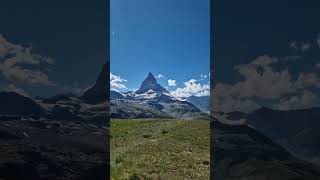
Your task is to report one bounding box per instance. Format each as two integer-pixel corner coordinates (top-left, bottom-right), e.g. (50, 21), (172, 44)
(212, 0), (320, 112)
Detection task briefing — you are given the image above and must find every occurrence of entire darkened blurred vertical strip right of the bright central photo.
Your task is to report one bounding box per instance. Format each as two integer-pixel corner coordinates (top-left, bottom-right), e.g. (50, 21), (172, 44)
(210, 0), (320, 180)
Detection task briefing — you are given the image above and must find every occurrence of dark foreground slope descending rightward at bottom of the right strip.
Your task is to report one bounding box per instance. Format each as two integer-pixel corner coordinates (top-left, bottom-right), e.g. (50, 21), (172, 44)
(211, 120), (320, 180)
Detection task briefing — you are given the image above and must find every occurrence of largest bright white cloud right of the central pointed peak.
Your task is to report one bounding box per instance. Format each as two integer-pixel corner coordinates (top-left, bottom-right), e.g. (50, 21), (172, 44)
(171, 79), (210, 99)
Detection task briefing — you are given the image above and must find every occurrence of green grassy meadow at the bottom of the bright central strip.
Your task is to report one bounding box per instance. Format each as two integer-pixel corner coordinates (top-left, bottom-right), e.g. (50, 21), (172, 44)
(110, 119), (210, 180)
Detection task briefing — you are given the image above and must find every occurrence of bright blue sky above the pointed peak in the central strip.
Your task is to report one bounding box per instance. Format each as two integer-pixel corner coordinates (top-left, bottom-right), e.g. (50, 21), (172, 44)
(110, 0), (210, 97)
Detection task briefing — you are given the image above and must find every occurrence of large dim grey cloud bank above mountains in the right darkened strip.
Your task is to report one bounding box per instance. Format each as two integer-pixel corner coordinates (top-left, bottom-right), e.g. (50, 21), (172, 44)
(212, 55), (320, 112)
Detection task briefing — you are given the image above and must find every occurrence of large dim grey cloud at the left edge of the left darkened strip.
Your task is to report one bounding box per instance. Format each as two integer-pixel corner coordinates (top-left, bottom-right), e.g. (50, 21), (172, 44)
(0, 35), (55, 86)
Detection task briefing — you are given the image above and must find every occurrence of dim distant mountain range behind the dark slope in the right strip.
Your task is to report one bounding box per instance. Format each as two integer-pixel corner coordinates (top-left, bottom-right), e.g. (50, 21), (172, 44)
(216, 107), (320, 165)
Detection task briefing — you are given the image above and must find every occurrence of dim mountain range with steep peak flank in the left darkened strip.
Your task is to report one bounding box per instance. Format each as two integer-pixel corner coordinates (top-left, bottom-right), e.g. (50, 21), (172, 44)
(0, 64), (109, 123)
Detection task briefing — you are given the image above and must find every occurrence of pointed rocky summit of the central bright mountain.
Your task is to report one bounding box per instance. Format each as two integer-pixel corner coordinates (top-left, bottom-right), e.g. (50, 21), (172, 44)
(136, 72), (169, 94)
